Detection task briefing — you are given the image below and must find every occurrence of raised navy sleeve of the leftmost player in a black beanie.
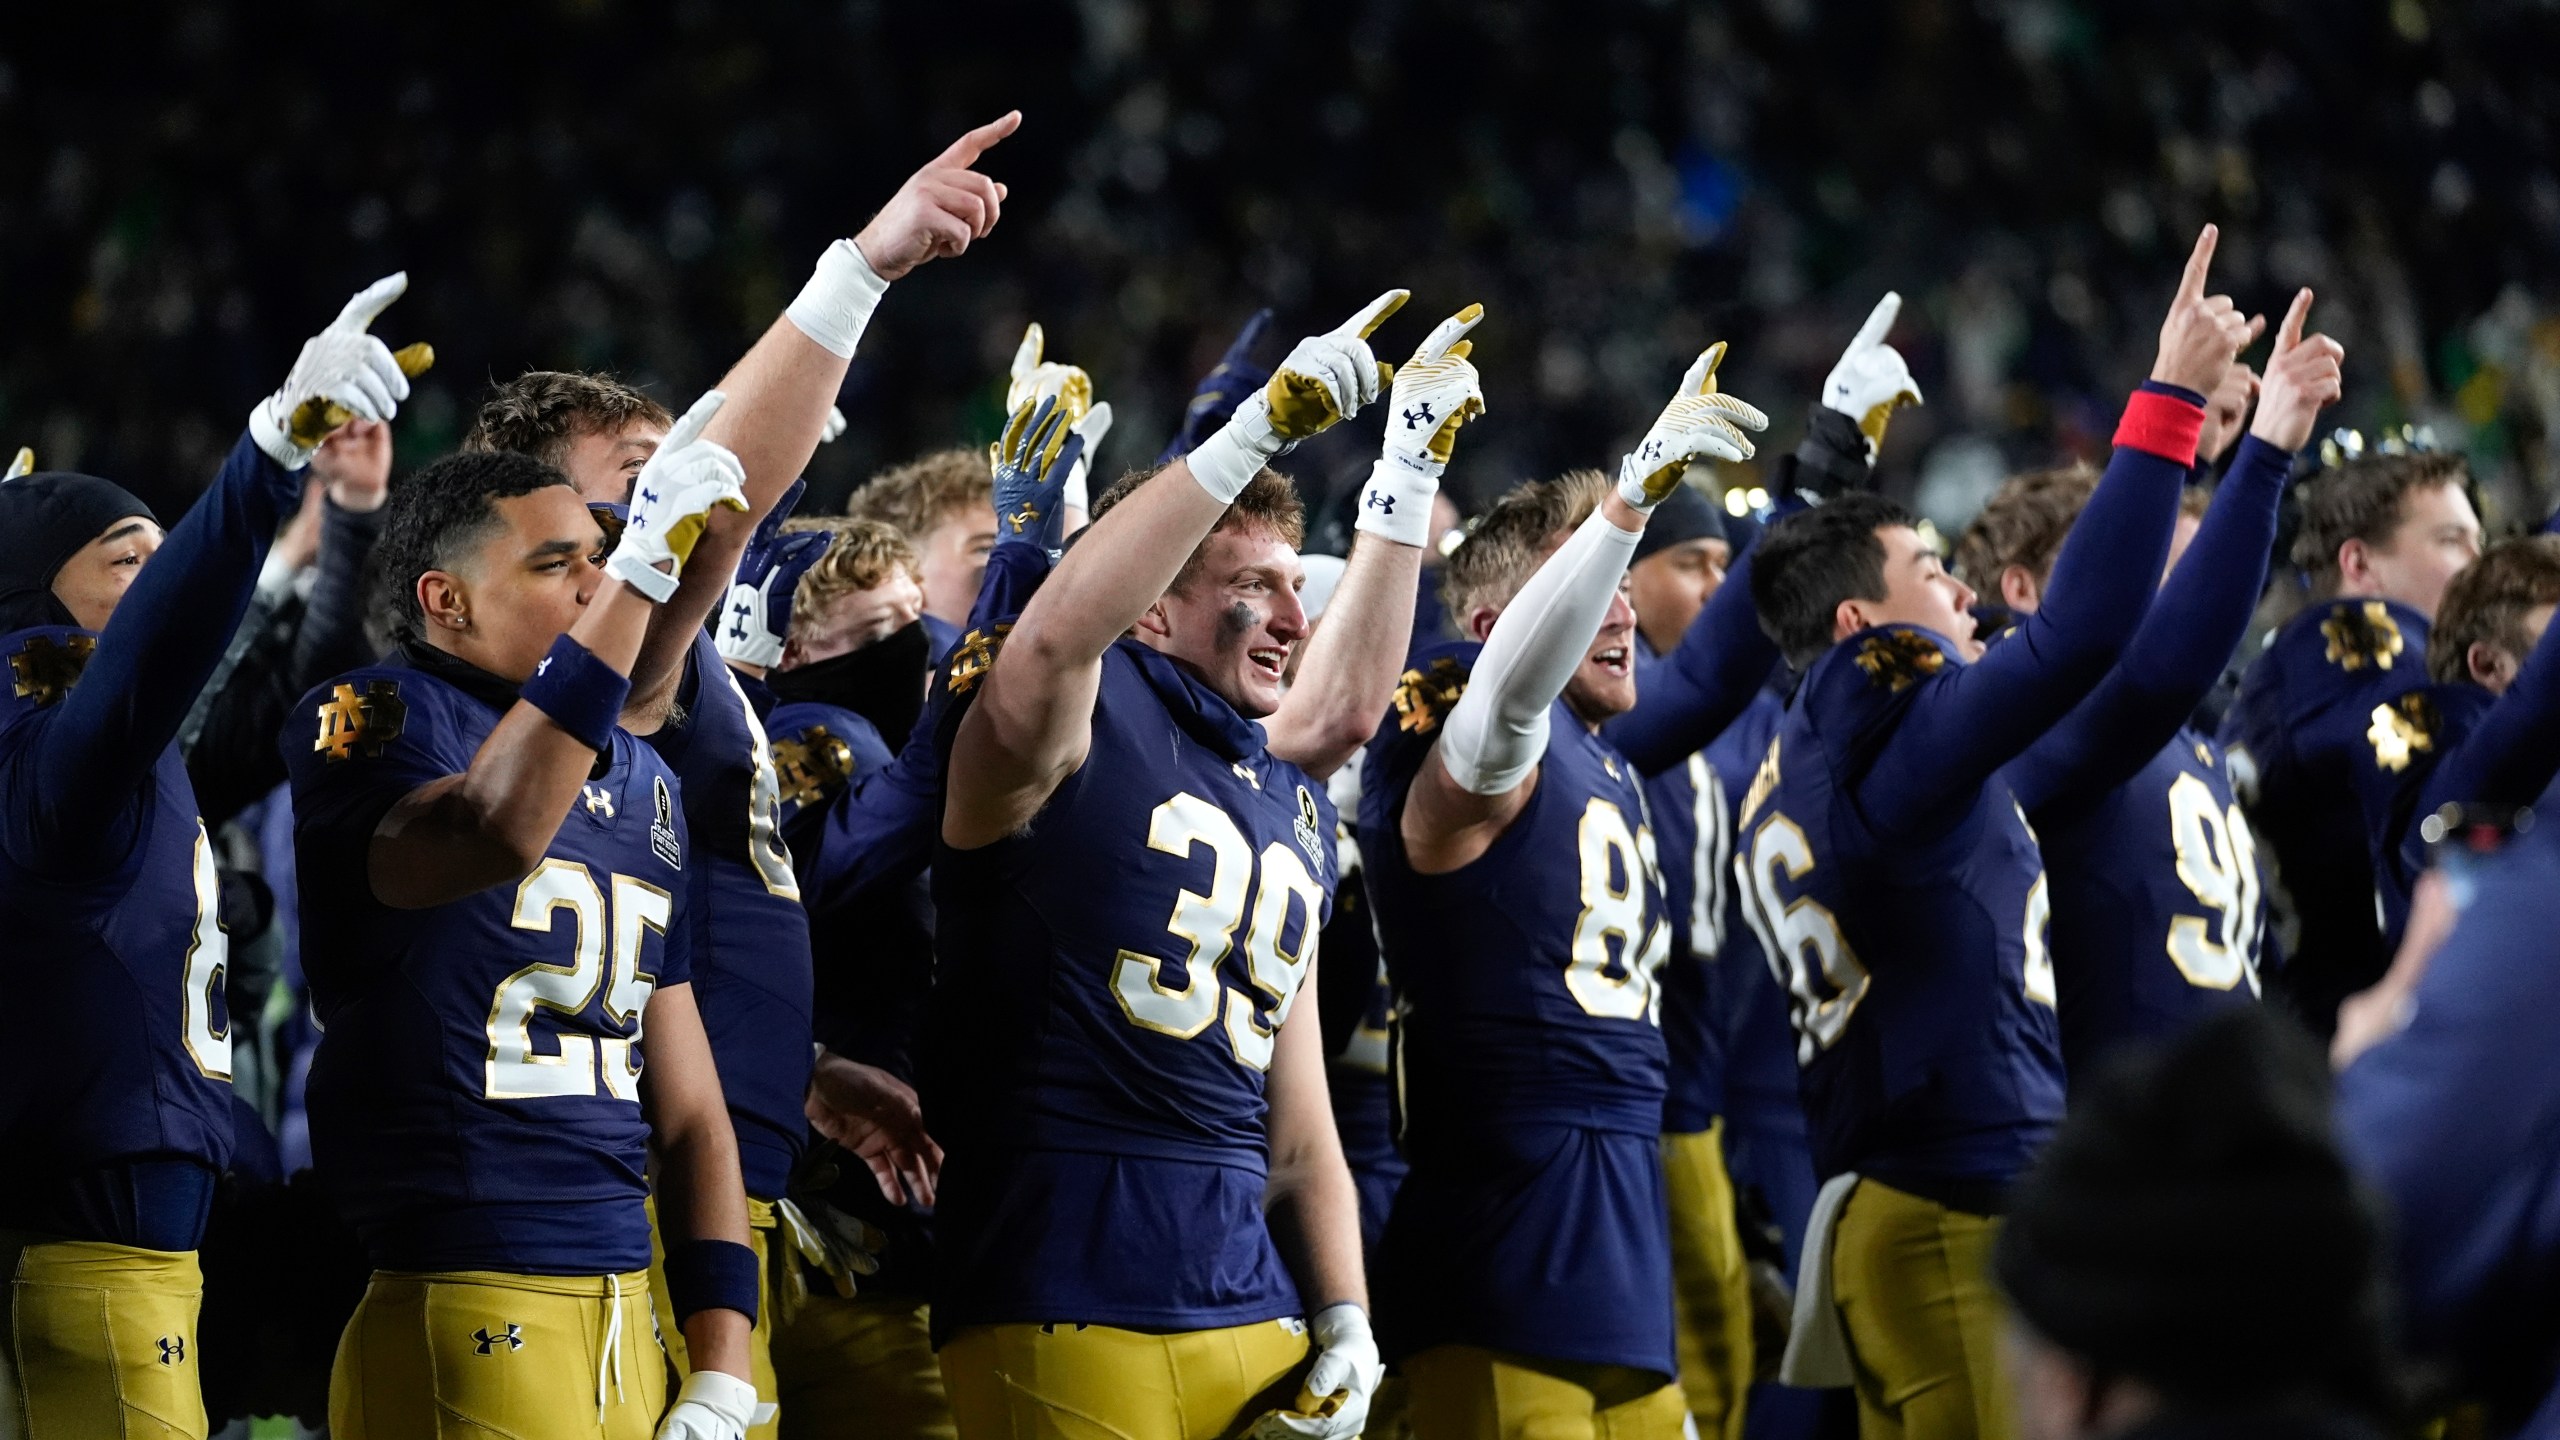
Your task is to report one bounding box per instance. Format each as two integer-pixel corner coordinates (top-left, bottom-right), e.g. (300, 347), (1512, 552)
(8, 433), (302, 856)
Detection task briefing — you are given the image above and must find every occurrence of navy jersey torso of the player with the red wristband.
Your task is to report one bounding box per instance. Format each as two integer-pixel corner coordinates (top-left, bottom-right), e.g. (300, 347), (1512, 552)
(1733, 625), (2063, 1194)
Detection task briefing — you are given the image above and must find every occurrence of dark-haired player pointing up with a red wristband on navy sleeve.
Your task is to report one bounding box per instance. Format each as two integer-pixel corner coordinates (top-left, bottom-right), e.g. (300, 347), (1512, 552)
(1733, 225), (2248, 1440)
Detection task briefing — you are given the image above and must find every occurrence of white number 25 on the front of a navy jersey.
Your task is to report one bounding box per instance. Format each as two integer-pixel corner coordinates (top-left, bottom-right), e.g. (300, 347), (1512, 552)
(481, 858), (673, 1102)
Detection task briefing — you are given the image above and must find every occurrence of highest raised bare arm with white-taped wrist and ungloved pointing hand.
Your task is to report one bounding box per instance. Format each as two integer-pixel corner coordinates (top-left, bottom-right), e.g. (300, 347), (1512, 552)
(632, 110), (1021, 723)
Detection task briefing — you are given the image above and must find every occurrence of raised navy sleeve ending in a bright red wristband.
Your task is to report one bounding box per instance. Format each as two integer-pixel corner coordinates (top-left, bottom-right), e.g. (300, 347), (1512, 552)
(1856, 382), (2204, 835)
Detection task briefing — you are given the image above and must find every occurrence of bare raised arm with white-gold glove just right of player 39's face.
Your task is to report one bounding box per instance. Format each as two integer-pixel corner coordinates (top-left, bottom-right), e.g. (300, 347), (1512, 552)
(1262, 305), (1485, 779)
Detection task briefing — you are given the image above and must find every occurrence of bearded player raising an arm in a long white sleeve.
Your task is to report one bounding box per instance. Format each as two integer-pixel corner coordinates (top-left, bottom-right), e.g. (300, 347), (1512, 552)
(1359, 346), (1766, 1440)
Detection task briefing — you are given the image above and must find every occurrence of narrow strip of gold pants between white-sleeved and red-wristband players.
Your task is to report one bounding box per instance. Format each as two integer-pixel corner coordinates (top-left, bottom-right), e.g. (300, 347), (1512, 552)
(1661, 1120), (1754, 1440)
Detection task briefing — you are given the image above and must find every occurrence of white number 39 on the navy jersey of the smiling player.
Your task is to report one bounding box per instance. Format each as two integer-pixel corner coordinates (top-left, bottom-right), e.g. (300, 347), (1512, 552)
(1111, 792), (1324, 1071)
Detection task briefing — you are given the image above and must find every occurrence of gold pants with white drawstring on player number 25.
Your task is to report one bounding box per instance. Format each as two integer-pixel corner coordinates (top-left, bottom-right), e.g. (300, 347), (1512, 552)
(328, 1271), (668, 1440)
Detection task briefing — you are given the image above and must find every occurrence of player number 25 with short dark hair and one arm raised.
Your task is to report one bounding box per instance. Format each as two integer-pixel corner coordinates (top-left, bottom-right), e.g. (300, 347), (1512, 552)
(284, 404), (758, 1440)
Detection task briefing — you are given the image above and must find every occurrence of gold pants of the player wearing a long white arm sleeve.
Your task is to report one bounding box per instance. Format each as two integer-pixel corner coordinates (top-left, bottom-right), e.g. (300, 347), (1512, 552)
(1403, 1345), (1690, 1440)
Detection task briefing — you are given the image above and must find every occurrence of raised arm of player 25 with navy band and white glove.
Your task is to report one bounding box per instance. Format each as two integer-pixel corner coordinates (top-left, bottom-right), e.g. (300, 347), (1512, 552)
(366, 389), (745, 910)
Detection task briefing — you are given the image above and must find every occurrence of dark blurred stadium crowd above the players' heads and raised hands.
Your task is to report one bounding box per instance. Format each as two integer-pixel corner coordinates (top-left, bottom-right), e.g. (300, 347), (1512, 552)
(0, 0), (2560, 530)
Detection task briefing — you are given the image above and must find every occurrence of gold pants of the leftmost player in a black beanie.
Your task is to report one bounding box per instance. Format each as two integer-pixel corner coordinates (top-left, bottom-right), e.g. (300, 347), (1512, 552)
(0, 1232), (205, 1440)
